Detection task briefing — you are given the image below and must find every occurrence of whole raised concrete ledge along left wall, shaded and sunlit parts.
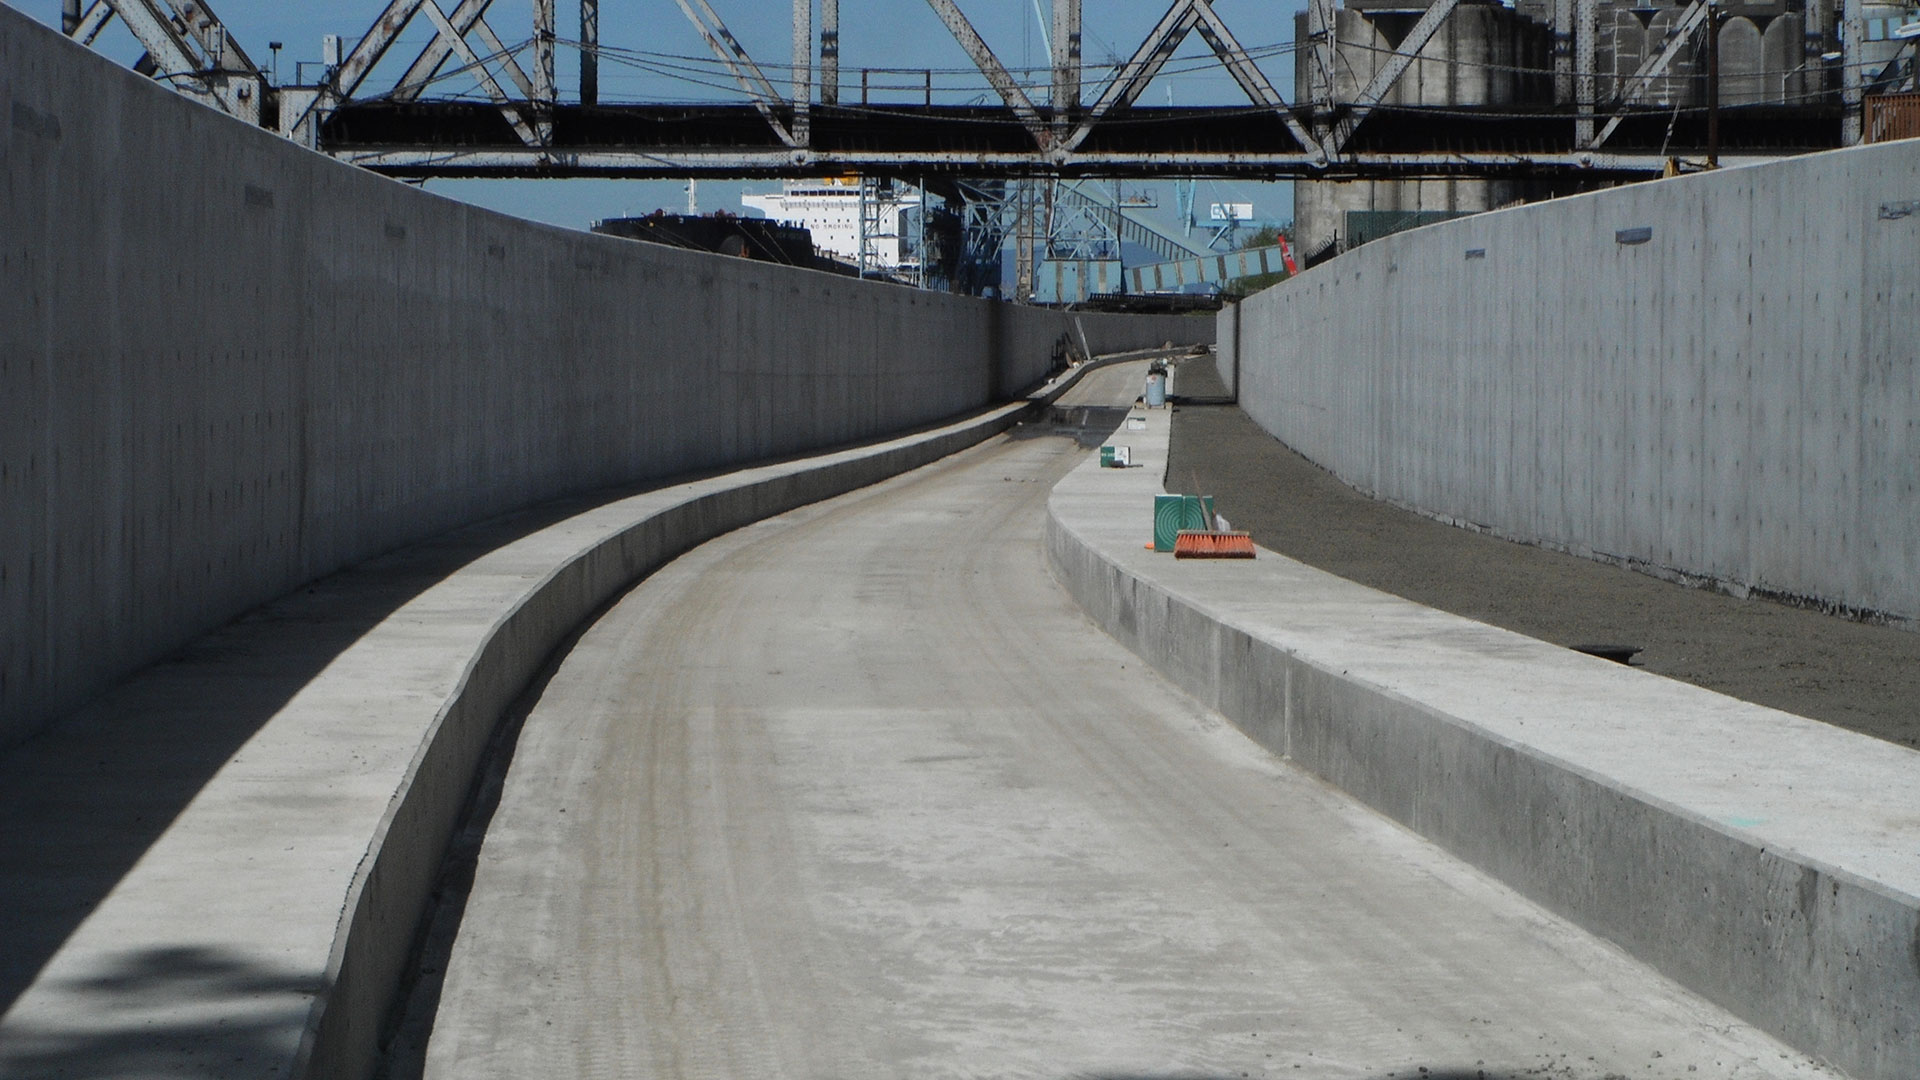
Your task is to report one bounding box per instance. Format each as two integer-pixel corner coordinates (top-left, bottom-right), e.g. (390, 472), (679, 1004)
(0, 363), (1121, 1080)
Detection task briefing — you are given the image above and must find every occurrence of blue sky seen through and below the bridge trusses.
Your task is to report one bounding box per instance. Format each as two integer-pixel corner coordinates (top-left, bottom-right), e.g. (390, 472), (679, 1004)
(8, 0), (1300, 229)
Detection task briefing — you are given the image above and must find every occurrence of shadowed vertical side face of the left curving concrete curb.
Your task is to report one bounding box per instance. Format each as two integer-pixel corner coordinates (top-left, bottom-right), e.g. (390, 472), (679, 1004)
(292, 354), (1133, 1078)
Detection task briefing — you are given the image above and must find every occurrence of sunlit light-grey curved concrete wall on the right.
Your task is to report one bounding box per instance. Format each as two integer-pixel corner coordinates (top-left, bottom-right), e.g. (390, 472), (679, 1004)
(1221, 142), (1920, 625)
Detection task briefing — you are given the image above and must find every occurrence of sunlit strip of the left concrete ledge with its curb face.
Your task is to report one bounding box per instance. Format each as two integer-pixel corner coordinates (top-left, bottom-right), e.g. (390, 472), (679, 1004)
(0, 354), (1167, 1080)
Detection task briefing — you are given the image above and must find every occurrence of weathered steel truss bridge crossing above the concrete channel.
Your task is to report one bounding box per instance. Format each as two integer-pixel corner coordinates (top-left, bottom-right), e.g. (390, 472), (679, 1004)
(65, 0), (1874, 182)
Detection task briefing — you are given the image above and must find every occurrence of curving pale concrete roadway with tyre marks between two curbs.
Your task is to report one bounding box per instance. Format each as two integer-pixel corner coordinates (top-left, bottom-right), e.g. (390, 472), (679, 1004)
(426, 369), (1832, 1080)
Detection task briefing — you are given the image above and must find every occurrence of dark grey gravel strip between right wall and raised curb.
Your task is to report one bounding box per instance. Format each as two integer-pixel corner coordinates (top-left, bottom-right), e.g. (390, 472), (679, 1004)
(1167, 359), (1920, 748)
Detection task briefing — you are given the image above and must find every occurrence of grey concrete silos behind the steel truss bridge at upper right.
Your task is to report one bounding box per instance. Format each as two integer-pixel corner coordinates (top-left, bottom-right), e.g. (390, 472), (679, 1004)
(1294, 0), (1916, 263)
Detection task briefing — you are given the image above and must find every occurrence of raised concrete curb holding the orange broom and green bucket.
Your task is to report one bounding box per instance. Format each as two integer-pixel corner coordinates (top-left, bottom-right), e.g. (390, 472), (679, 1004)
(1046, 397), (1920, 1080)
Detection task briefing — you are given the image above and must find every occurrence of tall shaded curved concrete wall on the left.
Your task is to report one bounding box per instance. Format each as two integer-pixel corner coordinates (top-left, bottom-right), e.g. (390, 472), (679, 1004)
(0, 8), (1212, 746)
